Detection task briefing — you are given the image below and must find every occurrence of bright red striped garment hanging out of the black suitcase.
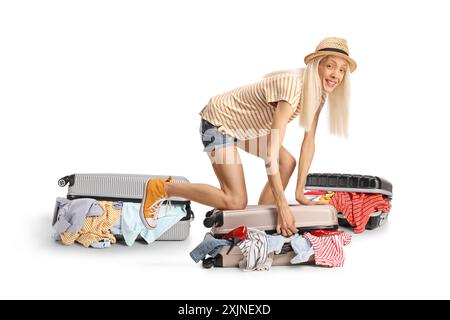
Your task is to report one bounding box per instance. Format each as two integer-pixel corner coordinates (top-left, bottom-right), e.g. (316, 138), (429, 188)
(330, 192), (391, 233)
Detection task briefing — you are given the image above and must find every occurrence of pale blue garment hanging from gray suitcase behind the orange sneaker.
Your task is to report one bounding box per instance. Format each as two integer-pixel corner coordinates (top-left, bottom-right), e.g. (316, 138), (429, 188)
(120, 202), (186, 246)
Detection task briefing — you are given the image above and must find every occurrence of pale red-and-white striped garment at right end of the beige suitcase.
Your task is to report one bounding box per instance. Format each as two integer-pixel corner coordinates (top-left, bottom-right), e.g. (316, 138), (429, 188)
(303, 232), (352, 268)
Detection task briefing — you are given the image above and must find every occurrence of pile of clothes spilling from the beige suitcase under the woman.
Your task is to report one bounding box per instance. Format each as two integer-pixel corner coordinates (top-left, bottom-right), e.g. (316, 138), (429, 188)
(190, 226), (351, 271)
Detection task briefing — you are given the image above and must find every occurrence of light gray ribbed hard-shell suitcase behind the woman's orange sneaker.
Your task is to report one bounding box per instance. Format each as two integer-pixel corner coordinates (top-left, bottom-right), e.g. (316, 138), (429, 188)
(53, 174), (194, 240)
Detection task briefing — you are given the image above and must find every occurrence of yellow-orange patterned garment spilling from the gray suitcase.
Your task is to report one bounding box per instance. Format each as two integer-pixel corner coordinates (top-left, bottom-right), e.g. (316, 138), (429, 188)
(61, 201), (122, 248)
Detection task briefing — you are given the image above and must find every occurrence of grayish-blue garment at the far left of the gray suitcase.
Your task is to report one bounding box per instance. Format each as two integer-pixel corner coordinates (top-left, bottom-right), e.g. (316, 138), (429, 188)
(53, 198), (103, 233)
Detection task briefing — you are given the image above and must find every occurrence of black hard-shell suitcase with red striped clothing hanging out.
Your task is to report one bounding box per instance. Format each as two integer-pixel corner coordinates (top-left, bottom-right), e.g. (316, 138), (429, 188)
(305, 173), (392, 230)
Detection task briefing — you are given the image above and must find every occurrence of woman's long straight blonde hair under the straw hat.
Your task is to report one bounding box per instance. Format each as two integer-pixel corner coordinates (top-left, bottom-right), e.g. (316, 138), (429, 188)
(264, 56), (350, 137)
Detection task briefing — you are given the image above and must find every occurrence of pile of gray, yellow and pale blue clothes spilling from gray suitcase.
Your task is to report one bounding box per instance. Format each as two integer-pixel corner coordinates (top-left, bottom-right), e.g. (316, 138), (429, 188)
(52, 198), (186, 249)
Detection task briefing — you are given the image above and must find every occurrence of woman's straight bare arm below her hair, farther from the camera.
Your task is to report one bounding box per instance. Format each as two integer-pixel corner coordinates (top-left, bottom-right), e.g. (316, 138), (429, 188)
(295, 105), (323, 205)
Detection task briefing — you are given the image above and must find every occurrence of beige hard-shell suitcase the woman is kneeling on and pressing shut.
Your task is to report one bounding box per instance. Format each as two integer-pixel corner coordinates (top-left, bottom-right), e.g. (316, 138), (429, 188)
(203, 204), (338, 268)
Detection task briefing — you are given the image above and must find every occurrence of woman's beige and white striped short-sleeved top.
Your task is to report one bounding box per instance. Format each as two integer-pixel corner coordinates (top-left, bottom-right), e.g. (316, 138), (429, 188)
(200, 69), (303, 140)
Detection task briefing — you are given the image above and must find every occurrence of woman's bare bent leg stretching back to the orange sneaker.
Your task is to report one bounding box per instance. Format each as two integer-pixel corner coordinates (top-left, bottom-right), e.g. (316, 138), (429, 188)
(166, 146), (247, 210)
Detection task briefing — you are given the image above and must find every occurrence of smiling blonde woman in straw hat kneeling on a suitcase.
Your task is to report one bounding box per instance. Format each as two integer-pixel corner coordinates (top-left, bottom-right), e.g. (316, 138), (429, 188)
(140, 38), (356, 236)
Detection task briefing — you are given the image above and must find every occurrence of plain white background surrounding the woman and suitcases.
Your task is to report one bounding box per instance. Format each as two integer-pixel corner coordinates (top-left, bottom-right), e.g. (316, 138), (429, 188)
(0, 0), (450, 299)
